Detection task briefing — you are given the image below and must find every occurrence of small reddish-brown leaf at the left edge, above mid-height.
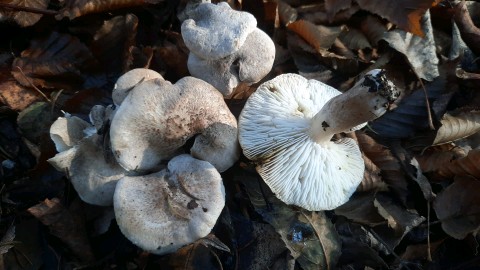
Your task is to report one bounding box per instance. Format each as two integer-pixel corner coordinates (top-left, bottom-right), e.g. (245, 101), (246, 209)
(0, 81), (43, 111)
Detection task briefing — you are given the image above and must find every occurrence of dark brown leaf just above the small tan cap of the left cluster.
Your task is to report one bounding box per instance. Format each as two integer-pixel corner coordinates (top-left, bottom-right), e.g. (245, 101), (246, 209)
(91, 14), (138, 75)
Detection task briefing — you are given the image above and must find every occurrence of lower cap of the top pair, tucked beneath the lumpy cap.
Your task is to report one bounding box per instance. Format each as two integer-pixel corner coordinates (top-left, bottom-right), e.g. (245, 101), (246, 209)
(188, 28), (275, 96)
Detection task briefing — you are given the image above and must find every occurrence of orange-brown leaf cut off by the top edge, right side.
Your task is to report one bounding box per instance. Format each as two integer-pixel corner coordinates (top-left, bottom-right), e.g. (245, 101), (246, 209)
(356, 0), (438, 36)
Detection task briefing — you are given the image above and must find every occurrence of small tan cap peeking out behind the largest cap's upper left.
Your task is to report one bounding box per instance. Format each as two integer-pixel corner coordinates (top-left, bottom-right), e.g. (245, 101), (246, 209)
(112, 68), (163, 106)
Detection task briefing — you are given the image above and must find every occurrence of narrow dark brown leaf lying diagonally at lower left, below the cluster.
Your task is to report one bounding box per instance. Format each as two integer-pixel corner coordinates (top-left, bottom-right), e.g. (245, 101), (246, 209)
(27, 198), (94, 262)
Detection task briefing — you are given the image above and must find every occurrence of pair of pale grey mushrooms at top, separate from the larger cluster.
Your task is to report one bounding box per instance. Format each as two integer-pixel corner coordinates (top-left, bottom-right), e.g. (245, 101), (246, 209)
(182, 2), (275, 96)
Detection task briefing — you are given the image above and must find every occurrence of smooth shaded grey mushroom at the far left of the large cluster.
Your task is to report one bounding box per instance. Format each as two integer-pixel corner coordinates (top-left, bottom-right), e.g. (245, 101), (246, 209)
(48, 134), (126, 206)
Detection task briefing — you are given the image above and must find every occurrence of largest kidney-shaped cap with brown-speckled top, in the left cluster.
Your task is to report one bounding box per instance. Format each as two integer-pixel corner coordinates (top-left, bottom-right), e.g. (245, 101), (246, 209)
(110, 77), (240, 172)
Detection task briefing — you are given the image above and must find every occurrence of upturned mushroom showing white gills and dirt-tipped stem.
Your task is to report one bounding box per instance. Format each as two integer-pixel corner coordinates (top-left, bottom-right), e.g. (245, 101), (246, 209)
(239, 70), (399, 211)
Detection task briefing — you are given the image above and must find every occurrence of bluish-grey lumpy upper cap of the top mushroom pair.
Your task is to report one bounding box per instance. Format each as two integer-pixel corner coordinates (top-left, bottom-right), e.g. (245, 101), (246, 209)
(182, 2), (257, 60)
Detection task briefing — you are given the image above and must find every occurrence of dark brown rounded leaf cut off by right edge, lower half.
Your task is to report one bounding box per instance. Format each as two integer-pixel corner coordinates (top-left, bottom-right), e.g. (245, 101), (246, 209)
(433, 176), (480, 239)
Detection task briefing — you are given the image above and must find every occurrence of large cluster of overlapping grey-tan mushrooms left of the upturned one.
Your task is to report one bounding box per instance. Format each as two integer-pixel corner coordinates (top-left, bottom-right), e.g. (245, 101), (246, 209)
(49, 69), (240, 254)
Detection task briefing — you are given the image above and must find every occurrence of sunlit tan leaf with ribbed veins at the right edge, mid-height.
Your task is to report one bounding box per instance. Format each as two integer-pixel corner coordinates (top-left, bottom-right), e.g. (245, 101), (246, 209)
(433, 111), (480, 145)
